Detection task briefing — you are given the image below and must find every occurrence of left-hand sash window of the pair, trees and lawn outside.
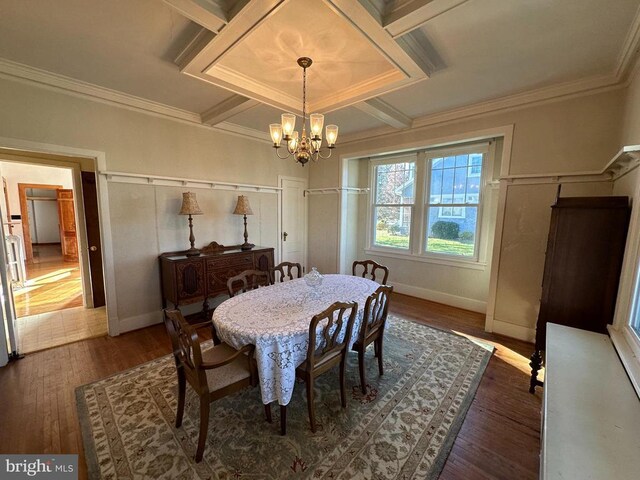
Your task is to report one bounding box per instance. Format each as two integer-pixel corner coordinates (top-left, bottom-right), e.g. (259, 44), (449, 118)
(372, 161), (416, 250)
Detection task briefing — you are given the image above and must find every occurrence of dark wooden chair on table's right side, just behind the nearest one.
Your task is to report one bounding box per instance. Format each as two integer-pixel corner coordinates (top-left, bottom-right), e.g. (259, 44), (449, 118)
(351, 285), (393, 395)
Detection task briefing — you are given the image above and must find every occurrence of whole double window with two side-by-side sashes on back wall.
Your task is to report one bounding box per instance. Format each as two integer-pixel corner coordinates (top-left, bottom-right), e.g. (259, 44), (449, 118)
(369, 144), (489, 261)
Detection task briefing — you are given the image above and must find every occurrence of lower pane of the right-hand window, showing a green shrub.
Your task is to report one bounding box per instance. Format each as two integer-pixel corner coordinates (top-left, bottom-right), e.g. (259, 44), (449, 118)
(427, 207), (478, 257)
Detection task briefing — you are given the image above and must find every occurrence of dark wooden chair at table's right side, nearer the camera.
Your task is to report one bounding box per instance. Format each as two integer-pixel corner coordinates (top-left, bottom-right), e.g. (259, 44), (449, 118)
(288, 302), (358, 435)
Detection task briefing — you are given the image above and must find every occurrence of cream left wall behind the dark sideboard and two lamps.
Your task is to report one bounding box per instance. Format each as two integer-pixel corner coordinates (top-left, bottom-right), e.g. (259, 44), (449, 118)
(0, 79), (308, 331)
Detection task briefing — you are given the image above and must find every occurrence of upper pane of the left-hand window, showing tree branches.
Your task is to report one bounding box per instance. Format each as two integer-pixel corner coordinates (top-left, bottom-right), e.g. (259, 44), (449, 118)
(376, 162), (416, 204)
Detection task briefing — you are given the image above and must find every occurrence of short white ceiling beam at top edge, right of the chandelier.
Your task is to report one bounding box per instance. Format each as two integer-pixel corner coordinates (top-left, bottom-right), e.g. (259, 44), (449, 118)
(382, 0), (468, 38)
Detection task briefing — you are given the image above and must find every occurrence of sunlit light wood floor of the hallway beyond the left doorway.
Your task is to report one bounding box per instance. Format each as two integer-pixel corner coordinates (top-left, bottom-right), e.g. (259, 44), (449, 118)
(13, 245), (107, 353)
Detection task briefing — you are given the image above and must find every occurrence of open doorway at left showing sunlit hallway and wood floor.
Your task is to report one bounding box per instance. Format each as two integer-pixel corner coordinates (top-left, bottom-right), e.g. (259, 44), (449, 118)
(0, 156), (107, 353)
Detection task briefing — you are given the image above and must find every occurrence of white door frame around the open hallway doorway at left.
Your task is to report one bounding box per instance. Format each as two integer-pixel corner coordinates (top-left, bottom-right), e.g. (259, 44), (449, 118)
(0, 137), (120, 336)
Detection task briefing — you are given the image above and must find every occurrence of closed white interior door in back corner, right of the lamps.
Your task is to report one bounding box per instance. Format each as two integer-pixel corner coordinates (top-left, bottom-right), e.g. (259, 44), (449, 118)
(280, 178), (307, 270)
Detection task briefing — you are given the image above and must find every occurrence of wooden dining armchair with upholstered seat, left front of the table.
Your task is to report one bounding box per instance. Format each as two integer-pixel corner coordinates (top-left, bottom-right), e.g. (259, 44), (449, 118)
(164, 309), (271, 462)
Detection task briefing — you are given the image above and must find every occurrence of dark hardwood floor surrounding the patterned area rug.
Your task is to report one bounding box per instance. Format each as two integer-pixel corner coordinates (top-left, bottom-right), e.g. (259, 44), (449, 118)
(0, 294), (542, 480)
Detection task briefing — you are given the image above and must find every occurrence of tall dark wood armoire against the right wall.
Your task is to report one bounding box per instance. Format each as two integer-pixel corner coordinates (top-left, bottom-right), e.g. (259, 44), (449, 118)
(529, 197), (631, 393)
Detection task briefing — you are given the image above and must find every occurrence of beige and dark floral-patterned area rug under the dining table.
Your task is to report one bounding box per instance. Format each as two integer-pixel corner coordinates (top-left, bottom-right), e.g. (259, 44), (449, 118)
(76, 316), (492, 479)
